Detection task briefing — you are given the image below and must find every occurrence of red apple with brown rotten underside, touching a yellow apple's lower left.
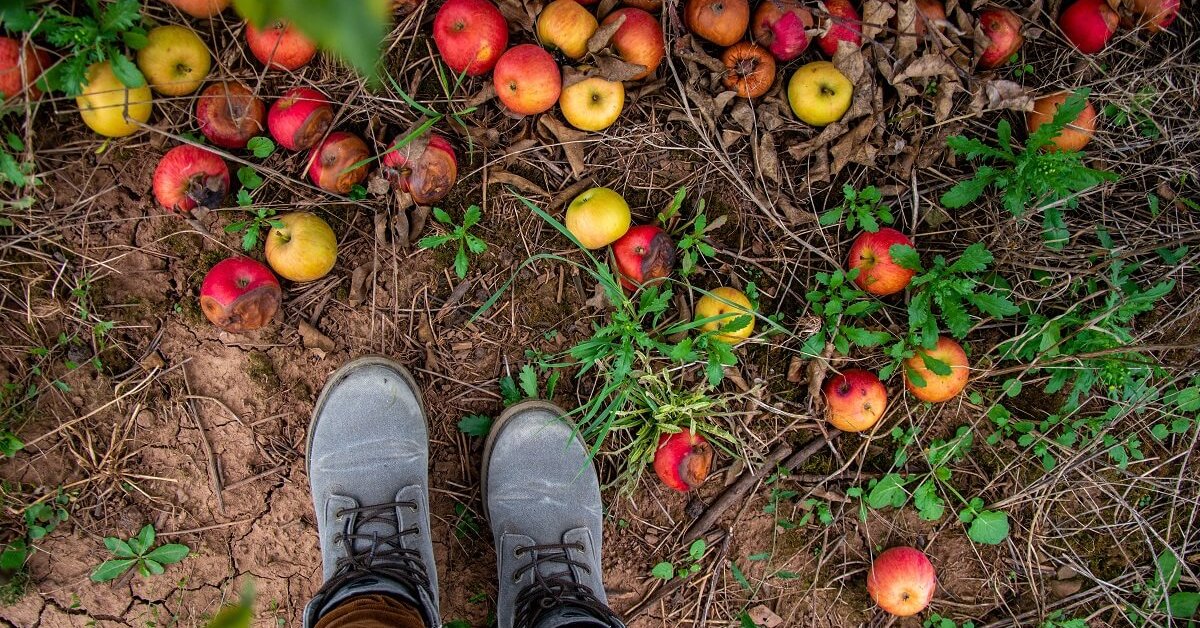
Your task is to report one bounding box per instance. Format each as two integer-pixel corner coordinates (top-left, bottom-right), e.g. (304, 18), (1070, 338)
(200, 256), (283, 333)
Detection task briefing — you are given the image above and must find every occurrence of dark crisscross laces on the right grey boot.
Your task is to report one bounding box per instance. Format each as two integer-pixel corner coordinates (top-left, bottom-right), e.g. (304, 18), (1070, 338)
(512, 543), (620, 628)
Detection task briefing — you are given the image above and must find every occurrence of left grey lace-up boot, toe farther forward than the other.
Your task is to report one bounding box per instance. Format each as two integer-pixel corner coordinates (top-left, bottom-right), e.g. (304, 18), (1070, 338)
(304, 357), (442, 628)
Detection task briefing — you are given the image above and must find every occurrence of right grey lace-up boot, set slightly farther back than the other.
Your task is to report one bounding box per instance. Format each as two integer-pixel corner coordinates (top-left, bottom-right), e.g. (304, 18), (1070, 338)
(482, 401), (624, 628)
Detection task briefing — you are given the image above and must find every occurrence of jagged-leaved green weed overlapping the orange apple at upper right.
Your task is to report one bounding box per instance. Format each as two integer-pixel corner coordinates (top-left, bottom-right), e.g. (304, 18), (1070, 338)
(942, 89), (1117, 249)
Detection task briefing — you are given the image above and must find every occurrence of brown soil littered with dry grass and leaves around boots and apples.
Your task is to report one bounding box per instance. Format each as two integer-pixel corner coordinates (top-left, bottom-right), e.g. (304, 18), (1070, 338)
(0, 0), (1200, 628)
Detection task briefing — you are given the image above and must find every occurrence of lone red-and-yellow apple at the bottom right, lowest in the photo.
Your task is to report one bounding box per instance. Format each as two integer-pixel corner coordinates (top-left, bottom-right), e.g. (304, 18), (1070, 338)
(866, 548), (937, 617)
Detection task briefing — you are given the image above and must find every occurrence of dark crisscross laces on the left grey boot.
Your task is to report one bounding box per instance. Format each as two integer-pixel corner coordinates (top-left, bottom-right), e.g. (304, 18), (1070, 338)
(320, 501), (434, 598)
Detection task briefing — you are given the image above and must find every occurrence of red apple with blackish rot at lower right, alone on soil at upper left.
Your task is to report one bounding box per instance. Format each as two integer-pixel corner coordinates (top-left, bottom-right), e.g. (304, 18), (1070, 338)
(154, 144), (229, 214)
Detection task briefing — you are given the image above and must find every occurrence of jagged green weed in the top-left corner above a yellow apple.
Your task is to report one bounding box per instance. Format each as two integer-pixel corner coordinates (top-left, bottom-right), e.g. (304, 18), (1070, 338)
(4, 0), (148, 96)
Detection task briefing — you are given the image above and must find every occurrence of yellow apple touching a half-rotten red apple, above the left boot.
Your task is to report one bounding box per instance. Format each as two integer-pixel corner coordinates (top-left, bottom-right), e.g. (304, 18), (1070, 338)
(266, 211), (337, 281)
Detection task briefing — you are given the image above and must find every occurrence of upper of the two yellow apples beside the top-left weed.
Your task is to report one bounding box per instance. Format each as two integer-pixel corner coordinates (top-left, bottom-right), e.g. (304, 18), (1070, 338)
(138, 25), (212, 96)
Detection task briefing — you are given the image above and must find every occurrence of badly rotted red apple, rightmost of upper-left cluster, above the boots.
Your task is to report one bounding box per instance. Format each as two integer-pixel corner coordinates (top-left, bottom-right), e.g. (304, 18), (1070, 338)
(383, 133), (458, 205)
